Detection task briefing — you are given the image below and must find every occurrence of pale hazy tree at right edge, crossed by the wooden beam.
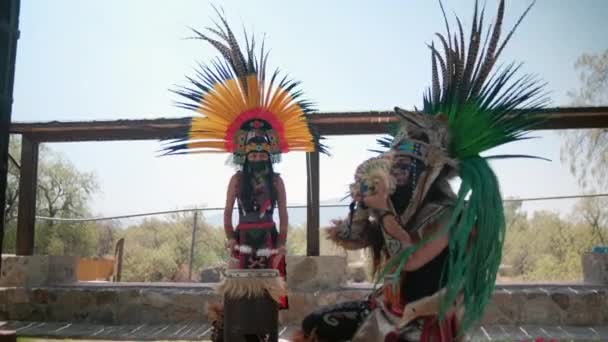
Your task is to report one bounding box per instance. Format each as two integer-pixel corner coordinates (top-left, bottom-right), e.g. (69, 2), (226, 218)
(562, 50), (608, 188)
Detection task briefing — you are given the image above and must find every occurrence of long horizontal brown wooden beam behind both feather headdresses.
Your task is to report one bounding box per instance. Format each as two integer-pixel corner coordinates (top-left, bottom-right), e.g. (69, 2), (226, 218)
(10, 107), (608, 142)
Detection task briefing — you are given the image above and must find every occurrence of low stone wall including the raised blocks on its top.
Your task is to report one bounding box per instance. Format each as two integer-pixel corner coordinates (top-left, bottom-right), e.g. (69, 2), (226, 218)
(0, 257), (608, 326)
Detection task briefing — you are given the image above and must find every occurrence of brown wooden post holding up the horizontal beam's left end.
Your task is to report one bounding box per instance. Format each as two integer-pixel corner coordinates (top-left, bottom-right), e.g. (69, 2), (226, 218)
(17, 135), (38, 255)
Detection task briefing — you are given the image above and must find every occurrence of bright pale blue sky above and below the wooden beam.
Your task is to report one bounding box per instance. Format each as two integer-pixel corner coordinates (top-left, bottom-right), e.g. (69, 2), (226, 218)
(13, 0), (608, 219)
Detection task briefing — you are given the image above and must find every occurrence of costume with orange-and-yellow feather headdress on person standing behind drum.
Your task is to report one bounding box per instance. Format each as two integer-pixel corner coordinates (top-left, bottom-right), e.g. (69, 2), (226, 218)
(163, 8), (325, 342)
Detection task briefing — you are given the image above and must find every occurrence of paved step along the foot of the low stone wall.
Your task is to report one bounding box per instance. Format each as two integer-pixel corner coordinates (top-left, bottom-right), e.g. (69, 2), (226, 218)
(0, 321), (608, 342)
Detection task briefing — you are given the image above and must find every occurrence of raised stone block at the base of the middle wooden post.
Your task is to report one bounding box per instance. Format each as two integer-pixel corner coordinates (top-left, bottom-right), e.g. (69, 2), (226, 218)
(287, 256), (348, 291)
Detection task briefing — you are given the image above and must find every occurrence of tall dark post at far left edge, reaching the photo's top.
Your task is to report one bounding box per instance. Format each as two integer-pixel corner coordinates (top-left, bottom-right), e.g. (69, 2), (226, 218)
(0, 0), (20, 269)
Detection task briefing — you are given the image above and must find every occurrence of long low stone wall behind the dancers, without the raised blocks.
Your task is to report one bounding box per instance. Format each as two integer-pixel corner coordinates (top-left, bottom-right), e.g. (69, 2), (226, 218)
(0, 284), (608, 326)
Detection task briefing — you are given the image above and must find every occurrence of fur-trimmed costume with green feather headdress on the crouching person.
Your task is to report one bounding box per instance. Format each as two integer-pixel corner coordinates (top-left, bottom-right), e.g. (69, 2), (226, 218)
(294, 1), (546, 341)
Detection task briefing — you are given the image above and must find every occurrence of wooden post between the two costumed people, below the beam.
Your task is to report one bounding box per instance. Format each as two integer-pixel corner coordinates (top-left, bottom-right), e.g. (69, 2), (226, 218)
(306, 152), (319, 256)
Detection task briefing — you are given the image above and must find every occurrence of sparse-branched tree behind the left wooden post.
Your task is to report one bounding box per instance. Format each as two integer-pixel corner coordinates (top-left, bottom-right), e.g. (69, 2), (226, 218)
(3, 139), (98, 256)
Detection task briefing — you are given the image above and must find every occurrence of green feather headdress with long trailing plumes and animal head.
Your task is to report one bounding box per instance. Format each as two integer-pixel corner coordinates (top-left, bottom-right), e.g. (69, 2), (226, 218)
(379, 0), (548, 332)
